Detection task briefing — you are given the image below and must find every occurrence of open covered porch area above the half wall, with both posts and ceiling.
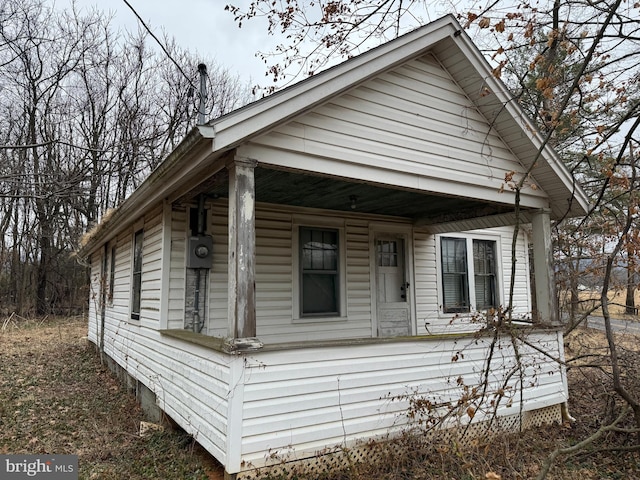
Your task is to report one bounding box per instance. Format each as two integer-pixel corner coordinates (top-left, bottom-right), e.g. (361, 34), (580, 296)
(171, 156), (557, 348)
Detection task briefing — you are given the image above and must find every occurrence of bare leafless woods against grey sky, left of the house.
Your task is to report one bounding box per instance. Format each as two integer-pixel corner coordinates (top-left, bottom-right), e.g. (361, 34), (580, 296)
(0, 0), (251, 314)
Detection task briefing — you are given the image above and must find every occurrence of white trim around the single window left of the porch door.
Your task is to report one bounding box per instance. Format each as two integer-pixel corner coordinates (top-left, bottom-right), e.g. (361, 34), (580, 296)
(291, 218), (347, 323)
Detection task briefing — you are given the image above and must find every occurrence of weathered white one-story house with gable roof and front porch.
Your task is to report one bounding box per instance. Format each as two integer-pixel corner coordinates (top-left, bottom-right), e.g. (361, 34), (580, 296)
(80, 16), (587, 475)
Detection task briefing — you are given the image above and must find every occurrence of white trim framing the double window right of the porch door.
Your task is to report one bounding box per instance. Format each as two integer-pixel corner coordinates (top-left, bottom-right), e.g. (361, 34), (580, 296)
(436, 232), (504, 317)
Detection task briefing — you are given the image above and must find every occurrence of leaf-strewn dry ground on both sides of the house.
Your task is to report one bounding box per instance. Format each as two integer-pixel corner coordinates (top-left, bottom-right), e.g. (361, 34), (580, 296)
(0, 316), (640, 480)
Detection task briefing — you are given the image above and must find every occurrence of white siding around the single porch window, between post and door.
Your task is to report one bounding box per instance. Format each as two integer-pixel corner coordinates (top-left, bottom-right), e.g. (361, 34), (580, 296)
(256, 208), (371, 343)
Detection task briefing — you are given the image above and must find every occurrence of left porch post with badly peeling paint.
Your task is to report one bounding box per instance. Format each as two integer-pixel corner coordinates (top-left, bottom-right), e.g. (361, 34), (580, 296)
(227, 157), (262, 350)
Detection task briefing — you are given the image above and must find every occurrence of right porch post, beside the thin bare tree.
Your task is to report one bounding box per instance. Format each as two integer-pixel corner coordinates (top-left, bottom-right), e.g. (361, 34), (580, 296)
(531, 209), (559, 325)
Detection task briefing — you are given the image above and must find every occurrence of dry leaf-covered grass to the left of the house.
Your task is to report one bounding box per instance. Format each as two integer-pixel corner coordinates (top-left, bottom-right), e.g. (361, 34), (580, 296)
(0, 317), (225, 480)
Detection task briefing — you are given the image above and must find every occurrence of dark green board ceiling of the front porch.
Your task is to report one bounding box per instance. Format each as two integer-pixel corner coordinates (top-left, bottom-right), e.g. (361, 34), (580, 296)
(179, 166), (513, 224)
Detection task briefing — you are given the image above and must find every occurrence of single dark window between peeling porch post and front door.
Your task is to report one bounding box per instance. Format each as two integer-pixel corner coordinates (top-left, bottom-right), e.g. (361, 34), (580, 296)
(300, 227), (340, 316)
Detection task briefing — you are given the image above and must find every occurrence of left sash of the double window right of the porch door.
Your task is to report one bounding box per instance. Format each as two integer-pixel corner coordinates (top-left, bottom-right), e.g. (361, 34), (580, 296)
(440, 237), (469, 313)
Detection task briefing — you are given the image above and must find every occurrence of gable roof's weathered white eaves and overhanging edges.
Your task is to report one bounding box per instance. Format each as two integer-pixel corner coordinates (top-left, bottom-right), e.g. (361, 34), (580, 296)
(81, 15), (588, 254)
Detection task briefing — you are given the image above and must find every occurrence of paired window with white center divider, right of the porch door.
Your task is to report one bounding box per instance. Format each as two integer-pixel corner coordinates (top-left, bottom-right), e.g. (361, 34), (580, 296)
(440, 237), (498, 313)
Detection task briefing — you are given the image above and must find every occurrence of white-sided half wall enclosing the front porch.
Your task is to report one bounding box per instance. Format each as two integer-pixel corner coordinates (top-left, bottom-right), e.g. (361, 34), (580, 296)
(154, 327), (568, 474)
